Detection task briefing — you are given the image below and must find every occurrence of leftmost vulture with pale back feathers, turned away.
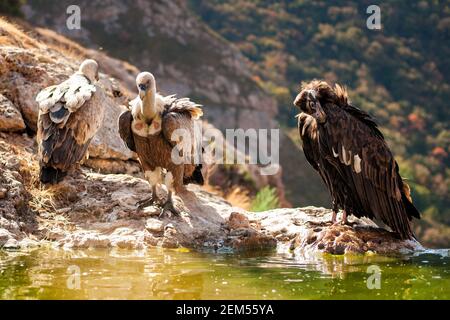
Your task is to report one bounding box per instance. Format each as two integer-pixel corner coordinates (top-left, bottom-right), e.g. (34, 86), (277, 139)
(36, 60), (104, 184)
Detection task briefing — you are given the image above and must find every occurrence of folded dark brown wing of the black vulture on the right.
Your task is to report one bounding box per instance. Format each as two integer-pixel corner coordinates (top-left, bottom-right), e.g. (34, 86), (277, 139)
(319, 104), (415, 238)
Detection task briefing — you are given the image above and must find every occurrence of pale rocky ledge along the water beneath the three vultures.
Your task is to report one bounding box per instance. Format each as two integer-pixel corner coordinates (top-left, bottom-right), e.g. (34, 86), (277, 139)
(0, 134), (421, 255)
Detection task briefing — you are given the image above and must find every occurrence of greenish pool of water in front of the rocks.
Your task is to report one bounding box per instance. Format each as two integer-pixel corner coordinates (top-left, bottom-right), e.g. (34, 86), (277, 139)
(0, 249), (450, 299)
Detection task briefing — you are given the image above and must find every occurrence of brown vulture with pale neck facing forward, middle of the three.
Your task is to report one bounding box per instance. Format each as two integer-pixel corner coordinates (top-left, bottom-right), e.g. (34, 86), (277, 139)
(119, 72), (203, 215)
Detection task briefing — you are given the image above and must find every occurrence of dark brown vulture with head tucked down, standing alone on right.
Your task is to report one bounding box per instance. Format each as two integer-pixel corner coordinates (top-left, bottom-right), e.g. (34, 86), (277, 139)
(294, 80), (420, 239)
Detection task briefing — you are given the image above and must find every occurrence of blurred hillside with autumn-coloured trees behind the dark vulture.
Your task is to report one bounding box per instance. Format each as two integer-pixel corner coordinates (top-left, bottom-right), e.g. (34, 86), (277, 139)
(190, 0), (450, 230)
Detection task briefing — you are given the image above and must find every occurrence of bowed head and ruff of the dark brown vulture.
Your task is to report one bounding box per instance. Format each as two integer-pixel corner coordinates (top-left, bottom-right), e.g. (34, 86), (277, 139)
(294, 80), (347, 123)
